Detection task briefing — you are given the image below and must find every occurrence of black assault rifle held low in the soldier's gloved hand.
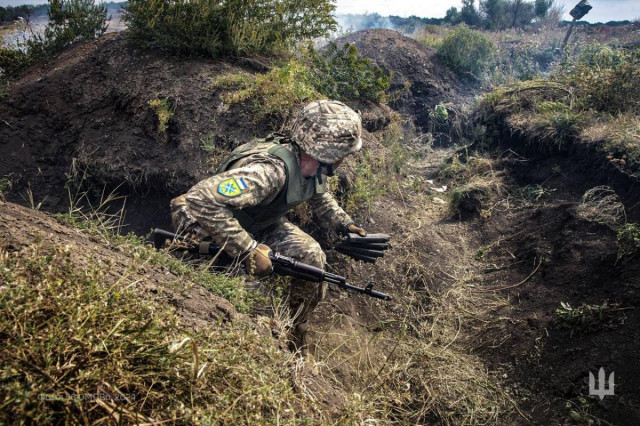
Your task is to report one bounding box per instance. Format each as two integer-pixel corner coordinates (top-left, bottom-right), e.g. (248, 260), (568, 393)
(152, 229), (392, 300)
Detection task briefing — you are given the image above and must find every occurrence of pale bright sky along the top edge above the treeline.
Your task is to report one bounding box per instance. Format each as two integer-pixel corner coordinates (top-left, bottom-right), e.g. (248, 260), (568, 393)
(0, 0), (640, 22)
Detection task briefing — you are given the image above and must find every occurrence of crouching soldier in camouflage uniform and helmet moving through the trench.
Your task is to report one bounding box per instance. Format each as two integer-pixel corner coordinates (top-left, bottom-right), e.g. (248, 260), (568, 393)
(171, 100), (367, 356)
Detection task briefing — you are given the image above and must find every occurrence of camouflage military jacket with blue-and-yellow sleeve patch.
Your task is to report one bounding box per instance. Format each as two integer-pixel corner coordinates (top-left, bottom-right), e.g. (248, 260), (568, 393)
(186, 135), (351, 256)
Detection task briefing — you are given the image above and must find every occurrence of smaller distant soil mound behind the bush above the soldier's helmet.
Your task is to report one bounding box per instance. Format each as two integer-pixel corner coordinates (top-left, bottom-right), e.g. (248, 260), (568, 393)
(336, 29), (474, 132)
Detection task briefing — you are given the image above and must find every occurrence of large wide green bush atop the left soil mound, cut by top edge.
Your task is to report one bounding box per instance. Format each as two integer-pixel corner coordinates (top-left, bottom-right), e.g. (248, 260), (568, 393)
(123, 0), (336, 57)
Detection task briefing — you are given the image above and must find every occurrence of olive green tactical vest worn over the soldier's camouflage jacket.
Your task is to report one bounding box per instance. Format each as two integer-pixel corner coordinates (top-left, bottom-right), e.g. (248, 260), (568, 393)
(216, 134), (326, 234)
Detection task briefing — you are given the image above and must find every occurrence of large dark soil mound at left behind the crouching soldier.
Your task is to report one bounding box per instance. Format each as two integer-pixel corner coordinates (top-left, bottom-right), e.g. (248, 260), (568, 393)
(0, 33), (391, 233)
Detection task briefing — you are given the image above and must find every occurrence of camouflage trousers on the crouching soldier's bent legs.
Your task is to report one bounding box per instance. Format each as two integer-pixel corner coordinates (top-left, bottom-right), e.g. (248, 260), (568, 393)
(171, 196), (327, 325)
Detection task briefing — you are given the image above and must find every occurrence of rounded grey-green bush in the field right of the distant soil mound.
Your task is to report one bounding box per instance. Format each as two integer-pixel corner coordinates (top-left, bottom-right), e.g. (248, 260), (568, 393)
(438, 26), (496, 78)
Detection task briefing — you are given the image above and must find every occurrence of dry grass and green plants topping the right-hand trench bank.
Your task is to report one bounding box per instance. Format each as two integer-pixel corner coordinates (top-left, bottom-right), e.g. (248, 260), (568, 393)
(476, 44), (640, 176)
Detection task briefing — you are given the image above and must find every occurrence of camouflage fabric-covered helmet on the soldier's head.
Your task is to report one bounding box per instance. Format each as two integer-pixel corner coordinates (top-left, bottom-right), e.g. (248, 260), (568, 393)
(291, 100), (362, 164)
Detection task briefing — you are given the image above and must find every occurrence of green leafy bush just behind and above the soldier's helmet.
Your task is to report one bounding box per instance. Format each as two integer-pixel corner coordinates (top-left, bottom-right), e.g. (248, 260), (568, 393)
(310, 42), (391, 102)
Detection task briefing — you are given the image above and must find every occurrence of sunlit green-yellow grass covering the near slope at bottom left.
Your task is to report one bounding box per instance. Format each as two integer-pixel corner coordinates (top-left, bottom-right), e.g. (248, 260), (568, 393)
(0, 241), (320, 424)
